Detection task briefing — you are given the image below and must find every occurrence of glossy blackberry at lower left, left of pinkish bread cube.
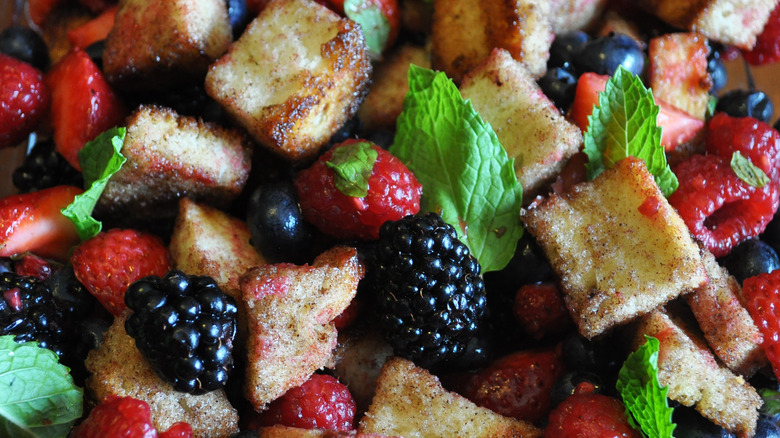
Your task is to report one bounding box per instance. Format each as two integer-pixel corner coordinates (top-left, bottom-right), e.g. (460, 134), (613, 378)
(125, 271), (238, 394)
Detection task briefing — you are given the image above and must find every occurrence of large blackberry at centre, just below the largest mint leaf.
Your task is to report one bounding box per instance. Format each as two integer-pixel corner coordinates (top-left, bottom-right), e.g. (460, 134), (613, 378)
(370, 213), (487, 369)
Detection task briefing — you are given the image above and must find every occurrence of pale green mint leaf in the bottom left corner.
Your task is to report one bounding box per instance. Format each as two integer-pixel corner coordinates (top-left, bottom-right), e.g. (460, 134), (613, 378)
(0, 335), (83, 437)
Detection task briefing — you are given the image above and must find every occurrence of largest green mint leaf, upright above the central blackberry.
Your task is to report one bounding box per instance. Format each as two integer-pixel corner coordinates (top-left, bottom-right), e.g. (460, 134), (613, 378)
(390, 65), (523, 272)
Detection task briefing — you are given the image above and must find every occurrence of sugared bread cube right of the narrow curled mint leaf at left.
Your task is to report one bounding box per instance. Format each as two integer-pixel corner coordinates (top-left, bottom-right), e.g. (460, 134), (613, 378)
(96, 105), (251, 220)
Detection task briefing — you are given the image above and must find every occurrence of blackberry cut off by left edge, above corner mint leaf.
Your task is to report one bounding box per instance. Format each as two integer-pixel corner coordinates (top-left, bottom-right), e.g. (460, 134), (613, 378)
(0, 272), (70, 357)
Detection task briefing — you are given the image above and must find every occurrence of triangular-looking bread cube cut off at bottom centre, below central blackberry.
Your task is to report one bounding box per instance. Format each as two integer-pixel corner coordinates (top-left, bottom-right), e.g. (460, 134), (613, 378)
(358, 357), (542, 438)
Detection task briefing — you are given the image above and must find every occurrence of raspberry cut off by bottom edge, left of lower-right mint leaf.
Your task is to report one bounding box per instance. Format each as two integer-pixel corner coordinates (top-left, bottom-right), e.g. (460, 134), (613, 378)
(544, 384), (642, 438)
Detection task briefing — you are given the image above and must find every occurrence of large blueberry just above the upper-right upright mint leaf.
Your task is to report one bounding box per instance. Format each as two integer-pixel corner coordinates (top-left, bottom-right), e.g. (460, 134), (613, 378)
(574, 33), (645, 75)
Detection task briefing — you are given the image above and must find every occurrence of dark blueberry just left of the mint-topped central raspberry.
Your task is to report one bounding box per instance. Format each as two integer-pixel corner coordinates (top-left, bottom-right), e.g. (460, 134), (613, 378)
(247, 182), (312, 263)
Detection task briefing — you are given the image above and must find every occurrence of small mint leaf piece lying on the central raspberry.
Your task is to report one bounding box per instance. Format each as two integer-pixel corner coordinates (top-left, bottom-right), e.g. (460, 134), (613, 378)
(325, 141), (379, 198)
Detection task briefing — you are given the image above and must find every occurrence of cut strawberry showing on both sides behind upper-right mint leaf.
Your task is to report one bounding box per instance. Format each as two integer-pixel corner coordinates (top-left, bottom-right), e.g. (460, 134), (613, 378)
(569, 73), (704, 151)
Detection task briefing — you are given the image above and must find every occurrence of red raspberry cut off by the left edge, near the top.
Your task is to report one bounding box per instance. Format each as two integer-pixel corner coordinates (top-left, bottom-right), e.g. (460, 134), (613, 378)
(0, 53), (50, 148)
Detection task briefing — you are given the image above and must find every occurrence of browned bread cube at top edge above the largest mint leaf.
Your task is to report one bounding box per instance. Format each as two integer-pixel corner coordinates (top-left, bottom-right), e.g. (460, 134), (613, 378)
(431, 0), (555, 83)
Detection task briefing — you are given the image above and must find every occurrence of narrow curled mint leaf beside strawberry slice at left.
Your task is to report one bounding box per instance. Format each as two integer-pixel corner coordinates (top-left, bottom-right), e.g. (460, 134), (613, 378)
(62, 127), (127, 240)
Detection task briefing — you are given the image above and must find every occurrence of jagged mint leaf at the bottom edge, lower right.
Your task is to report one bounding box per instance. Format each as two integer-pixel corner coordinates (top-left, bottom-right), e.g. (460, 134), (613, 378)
(616, 336), (676, 438)
